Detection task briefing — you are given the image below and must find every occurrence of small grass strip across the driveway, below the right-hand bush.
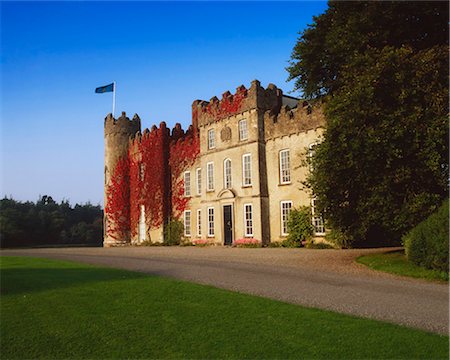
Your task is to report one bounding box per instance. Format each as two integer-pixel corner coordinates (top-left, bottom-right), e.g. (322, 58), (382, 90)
(356, 250), (448, 281)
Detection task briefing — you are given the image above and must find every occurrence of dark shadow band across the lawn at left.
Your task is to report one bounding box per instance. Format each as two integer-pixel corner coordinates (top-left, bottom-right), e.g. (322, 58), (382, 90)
(0, 267), (144, 296)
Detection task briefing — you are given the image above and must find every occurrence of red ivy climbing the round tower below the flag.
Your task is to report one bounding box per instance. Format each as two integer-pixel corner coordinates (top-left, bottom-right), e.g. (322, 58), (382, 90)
(105, 156), (130, 240)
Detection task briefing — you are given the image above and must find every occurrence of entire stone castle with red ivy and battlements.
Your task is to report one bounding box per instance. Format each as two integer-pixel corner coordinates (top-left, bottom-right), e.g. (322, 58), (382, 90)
(104, 80), (325, 246)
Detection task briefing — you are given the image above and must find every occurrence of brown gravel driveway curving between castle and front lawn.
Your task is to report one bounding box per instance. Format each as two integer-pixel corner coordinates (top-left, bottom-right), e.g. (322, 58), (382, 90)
(0, 247), (449, 334)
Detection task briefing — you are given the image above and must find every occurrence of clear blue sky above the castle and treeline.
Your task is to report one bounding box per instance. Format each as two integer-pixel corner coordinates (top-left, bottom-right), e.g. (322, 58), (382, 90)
(0, 1), (327, 204)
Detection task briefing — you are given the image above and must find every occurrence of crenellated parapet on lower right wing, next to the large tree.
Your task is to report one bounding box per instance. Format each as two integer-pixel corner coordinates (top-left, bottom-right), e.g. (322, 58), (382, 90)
(264, 101), (325, 140)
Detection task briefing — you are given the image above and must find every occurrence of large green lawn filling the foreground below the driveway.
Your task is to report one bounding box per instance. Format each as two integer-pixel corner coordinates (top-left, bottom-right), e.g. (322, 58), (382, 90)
(0, 257), (449, 359)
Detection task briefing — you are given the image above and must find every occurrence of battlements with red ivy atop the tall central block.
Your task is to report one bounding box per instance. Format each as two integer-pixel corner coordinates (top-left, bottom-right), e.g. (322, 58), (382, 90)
(192, 80), (283, 128)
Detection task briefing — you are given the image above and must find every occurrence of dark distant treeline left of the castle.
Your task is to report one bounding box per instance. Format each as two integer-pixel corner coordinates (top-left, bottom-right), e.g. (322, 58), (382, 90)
(0, 195), (103, 248)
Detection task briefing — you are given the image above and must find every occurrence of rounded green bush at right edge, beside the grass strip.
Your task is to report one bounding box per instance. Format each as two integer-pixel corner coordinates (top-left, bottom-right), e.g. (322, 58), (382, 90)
(402, 200), (449, 273)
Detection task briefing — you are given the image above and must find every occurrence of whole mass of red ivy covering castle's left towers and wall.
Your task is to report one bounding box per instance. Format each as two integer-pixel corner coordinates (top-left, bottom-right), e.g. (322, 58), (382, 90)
(105, 128), (200, 239)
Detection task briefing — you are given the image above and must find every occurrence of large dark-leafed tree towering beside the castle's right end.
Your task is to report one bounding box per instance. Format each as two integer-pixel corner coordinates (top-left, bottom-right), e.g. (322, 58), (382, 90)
(288, 2), (449, 246)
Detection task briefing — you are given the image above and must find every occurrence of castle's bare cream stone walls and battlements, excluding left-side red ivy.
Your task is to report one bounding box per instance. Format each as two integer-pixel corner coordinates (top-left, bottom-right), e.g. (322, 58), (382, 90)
(105, 80), (325, 246)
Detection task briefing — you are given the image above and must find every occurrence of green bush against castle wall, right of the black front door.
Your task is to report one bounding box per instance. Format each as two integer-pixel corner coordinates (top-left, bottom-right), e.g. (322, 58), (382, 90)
(283, 206), (314, 247)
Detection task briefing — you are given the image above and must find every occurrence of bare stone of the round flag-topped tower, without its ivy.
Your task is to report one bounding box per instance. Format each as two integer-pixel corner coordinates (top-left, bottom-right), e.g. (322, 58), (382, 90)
(103, 112), (141, 247)
